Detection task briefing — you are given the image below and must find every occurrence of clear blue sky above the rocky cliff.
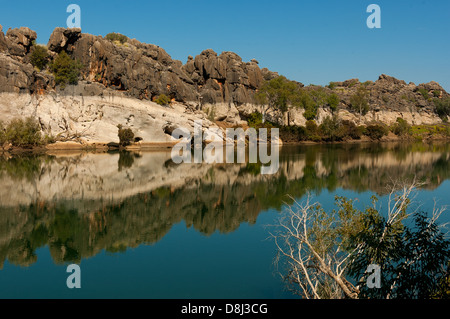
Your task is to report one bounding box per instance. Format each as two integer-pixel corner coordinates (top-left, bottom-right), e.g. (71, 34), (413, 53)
(0, 0), (450, 91)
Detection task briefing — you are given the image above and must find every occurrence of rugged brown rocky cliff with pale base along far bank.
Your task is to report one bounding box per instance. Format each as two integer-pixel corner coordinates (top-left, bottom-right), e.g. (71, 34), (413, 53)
(0, 26), (449, 142)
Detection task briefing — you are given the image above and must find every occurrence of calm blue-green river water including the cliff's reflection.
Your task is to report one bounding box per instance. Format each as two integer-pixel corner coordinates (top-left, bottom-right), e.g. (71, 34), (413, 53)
(0, 144), (450, 299)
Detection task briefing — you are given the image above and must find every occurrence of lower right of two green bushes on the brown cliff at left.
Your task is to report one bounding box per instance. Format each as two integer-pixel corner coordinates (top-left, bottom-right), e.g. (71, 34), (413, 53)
(50, 51), (82, 88)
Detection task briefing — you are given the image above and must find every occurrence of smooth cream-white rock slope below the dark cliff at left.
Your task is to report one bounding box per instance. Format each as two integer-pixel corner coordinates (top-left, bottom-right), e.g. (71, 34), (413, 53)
(0, 93), (225, 144)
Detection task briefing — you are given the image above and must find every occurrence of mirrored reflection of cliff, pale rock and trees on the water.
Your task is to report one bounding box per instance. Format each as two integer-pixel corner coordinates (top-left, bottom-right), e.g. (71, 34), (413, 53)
(0, 144), (450, 268)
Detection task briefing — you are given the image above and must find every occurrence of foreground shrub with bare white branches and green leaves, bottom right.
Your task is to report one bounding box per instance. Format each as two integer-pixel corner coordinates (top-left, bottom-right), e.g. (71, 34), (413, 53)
(272, 183), (450, 299)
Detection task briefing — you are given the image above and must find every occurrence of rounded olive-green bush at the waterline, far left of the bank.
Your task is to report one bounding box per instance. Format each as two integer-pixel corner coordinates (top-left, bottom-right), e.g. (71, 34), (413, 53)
(3, 117), (43, 147)
